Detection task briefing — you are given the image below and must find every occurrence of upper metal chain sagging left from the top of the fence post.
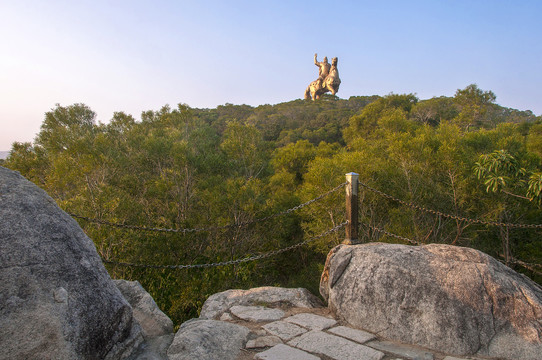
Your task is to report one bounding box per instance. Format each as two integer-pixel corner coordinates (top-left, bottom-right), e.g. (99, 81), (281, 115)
(68, 182), (347, 234)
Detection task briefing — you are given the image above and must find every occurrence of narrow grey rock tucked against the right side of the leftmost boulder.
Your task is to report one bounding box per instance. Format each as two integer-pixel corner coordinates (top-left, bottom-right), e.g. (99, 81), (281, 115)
(113, 280), (174, 360)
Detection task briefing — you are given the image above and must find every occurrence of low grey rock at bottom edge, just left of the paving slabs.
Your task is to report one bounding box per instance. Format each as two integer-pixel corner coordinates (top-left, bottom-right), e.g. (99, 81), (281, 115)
(167, 320), (250, 360)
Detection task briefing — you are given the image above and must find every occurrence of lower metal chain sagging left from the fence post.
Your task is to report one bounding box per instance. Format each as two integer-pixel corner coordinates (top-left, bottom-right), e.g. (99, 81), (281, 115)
(103, 221), (348, 269)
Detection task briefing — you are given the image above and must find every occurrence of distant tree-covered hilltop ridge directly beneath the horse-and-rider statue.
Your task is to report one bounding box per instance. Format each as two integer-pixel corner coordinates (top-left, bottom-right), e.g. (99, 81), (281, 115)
(189, 85), (537, 146)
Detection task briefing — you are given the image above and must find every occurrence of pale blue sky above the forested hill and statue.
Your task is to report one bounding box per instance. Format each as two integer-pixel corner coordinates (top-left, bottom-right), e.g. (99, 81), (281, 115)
(0, 0), (542, 150)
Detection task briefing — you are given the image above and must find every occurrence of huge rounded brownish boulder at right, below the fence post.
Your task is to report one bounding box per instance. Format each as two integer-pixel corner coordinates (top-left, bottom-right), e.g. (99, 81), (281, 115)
(320, 243), (542, 360)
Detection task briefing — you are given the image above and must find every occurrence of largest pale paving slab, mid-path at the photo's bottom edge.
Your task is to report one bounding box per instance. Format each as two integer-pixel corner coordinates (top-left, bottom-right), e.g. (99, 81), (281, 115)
(288, 330), (385, 360)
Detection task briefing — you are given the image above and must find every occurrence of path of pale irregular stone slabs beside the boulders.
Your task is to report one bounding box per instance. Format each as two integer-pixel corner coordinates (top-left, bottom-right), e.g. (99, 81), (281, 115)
(222, 306), (498, 360)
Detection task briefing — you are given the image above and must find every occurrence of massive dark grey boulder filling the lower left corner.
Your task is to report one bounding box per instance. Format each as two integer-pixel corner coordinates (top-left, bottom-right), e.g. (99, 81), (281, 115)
(0, 167), (142, 359)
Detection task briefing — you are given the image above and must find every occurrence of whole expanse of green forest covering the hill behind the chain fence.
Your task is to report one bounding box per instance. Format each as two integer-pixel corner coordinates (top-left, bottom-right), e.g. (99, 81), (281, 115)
(2, 85), (542, 322)
